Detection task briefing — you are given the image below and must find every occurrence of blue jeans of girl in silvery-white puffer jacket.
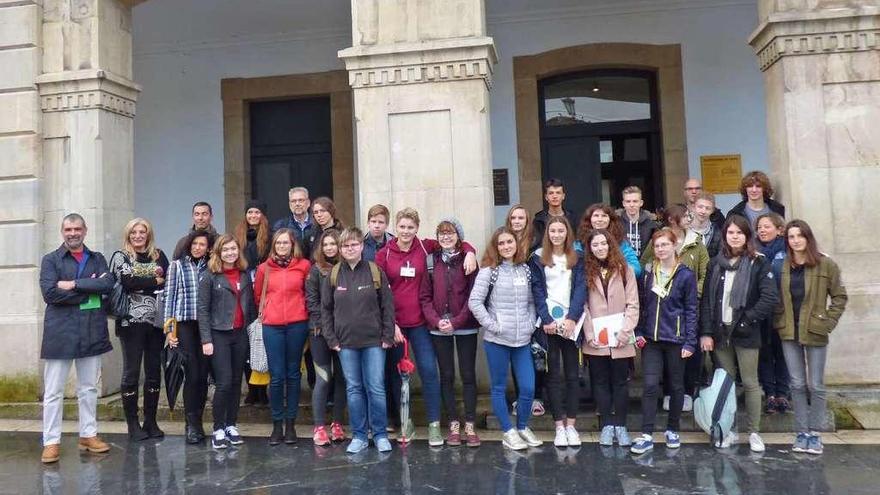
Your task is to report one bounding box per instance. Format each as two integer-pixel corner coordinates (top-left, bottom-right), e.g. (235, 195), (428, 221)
(483, 341), (535, 431)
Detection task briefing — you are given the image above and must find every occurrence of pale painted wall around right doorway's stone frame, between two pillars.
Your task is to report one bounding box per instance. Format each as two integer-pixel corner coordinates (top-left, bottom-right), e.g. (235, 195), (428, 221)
(489, 2), (768, 221)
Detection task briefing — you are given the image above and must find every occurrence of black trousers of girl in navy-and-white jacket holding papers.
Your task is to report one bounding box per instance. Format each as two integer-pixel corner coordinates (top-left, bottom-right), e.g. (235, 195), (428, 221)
(547, 335), (580, 421)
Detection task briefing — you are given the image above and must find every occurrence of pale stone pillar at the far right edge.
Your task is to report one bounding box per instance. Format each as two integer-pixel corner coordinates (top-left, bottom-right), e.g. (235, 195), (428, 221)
(749, 0), (880, 384)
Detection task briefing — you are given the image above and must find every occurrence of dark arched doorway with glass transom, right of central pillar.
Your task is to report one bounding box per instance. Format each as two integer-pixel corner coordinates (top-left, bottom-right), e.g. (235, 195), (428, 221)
(539, 69), (664, 221)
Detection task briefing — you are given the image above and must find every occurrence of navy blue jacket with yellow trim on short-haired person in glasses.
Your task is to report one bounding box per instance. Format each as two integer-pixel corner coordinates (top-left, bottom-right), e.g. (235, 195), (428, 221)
(636, 264), (699, 352)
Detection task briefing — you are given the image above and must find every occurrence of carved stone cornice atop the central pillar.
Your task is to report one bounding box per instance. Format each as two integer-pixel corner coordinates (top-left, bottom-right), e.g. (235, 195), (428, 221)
(339, 37), (498, 88)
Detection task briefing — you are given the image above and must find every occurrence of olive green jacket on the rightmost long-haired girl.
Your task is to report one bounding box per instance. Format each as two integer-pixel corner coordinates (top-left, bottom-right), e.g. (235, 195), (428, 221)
(773, 256), (847, 346)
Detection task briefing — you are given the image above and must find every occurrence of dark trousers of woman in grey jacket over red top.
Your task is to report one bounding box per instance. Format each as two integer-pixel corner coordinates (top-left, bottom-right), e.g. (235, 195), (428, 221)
(211, 328), (248, 431)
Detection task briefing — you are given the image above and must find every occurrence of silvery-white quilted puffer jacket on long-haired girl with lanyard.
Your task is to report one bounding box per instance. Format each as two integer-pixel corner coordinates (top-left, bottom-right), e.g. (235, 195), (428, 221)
(468, 261), (535, 347)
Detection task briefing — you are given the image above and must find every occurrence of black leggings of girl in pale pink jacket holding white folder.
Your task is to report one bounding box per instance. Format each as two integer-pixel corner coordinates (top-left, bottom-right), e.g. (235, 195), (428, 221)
(587, 355), (632, 427)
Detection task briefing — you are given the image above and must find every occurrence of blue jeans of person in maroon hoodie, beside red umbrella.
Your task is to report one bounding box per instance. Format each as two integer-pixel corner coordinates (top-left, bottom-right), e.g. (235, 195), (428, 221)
(391, 326), (440, 423)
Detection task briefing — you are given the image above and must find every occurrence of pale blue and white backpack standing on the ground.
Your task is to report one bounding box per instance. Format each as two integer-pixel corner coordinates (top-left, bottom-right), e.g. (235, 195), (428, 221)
(694, 368), (736, 447)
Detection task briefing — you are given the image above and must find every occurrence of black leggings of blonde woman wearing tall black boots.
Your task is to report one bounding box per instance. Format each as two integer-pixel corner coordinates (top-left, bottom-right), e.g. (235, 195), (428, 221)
(116, 323), (165, 395)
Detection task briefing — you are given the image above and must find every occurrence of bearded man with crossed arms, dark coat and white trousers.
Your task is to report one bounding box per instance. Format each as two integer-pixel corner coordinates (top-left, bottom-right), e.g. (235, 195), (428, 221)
(40, 213), (114, 464)
